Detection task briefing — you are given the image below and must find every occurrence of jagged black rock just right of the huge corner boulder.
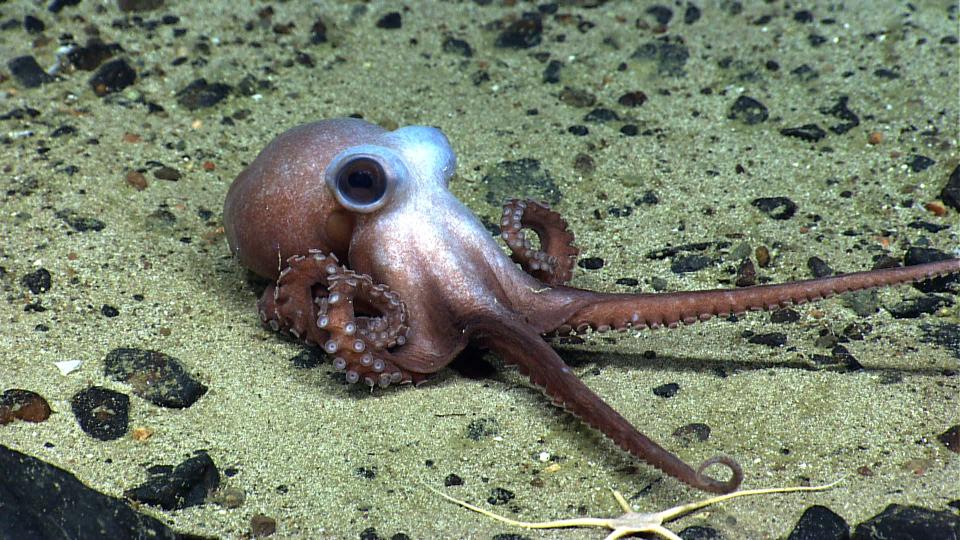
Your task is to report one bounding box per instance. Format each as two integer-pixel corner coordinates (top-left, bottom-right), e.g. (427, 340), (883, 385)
(123, 450), (220, 510)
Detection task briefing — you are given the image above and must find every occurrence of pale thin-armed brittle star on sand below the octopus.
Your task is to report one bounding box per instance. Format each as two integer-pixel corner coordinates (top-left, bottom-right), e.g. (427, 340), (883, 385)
(424, 480), (840, 540)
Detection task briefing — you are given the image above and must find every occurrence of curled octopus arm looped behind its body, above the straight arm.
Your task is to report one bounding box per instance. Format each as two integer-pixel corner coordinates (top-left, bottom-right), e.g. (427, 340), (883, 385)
(500, 199), (580, 285)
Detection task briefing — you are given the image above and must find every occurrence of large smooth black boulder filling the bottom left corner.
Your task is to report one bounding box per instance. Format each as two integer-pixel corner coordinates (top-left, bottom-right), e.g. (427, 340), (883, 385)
(0, 445), (179, 540)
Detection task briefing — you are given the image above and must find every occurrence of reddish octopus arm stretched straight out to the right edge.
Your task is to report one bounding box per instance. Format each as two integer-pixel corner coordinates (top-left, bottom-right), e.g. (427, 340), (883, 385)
(558, 259), (960, 332)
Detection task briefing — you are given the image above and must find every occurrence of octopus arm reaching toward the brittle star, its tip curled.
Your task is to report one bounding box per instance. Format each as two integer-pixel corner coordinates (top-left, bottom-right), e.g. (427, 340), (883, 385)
(468, 314), (743, 493)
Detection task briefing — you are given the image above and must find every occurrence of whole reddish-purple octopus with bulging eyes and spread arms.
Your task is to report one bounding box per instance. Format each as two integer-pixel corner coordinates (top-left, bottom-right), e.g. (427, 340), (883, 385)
(223, 118), (960, 493)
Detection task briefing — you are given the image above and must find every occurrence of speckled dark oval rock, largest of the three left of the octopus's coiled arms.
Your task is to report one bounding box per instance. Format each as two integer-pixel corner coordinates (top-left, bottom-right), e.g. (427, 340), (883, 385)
(103, 348), (207, 409)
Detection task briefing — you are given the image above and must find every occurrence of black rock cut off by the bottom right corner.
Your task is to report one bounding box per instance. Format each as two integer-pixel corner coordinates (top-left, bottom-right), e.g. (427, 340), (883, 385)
(851, 504), (960, 540)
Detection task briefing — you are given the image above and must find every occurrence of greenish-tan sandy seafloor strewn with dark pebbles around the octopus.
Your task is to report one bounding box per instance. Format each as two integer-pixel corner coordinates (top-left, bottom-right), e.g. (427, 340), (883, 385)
(0, 0), (960, 539)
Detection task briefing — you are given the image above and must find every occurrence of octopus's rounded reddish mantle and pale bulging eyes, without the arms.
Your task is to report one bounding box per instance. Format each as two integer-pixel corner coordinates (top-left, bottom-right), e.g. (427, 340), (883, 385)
(223, 118), (456, 279)
